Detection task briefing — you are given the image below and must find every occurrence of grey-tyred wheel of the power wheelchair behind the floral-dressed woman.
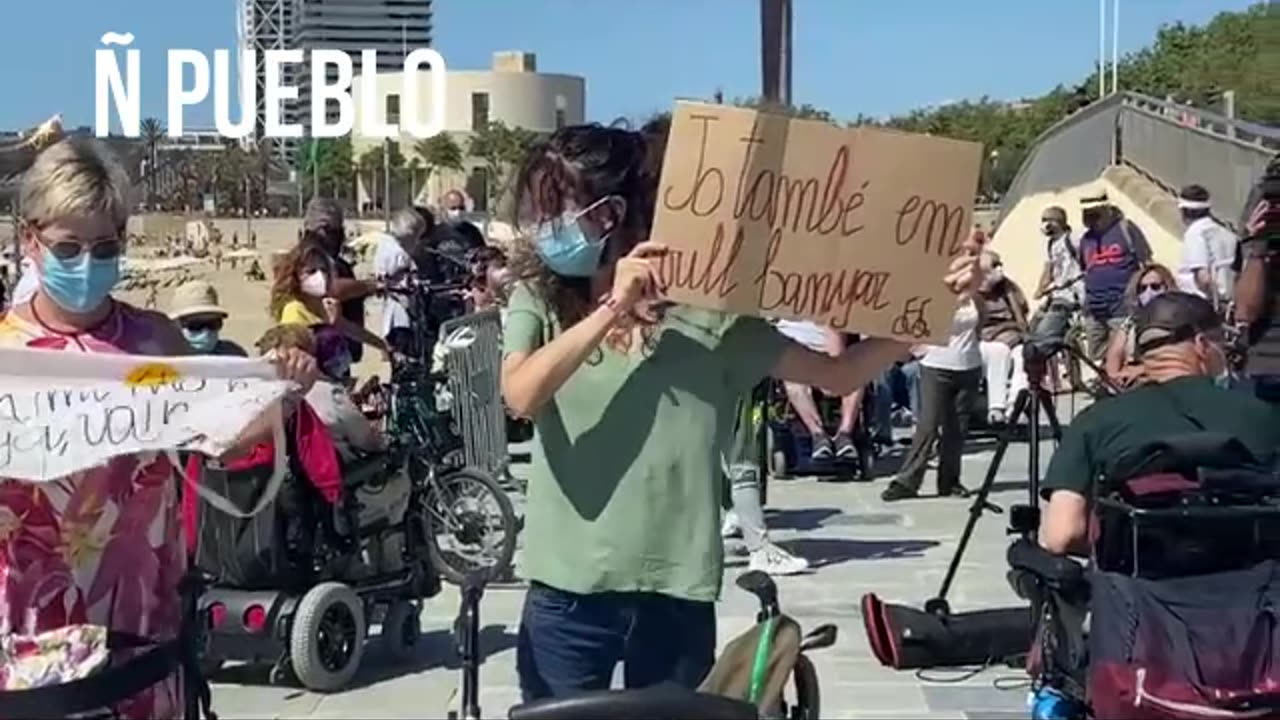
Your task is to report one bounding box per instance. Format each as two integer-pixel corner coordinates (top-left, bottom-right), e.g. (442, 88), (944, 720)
(289, 583), (366, 692)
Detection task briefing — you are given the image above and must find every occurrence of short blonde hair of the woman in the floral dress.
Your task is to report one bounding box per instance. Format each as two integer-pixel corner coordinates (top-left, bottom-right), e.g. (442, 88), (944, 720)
(19, 137), (131, 229)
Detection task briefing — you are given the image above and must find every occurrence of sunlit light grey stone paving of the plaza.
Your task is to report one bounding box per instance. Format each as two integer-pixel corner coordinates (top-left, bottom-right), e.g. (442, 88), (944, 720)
(214, 413), (1066, 719)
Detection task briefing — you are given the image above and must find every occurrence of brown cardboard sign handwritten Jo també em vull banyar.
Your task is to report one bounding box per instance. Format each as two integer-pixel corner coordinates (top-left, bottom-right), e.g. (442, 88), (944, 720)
(652, 102), (982, 342)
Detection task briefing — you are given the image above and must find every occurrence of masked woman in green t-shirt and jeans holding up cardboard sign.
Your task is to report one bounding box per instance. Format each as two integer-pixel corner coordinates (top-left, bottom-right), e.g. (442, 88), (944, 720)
(502, 120), (977, 700)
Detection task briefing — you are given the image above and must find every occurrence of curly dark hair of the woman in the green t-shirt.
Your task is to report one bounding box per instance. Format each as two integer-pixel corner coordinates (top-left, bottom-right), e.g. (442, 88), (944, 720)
(512, 122), (668, 328)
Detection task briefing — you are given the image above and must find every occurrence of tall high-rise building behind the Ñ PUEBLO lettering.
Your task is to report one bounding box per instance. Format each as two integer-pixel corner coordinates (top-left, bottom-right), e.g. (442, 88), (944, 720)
(237, 0), (433, 159)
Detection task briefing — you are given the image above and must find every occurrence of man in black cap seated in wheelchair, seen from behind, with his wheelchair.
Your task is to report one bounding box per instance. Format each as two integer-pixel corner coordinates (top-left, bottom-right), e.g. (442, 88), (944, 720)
(1024, 292), (1280, 719)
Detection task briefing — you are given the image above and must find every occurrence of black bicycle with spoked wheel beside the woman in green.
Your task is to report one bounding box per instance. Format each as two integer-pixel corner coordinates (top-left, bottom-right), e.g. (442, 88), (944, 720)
(380, 272), (518, 584)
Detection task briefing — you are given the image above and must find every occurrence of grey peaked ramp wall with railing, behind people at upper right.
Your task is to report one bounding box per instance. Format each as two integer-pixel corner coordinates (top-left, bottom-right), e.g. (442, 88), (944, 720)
(997, 92), (1280, 228)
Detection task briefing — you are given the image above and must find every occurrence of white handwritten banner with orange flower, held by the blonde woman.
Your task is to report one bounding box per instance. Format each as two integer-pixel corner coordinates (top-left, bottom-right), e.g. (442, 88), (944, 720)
(0, 350), (288, 482)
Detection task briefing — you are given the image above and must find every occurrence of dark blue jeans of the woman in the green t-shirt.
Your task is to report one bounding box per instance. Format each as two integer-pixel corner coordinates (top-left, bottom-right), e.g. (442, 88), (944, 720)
(516, 582), (716, 702)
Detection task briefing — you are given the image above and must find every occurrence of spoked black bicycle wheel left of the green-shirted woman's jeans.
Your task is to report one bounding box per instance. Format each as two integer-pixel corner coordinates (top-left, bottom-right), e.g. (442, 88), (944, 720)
(424, 468), (517, 585)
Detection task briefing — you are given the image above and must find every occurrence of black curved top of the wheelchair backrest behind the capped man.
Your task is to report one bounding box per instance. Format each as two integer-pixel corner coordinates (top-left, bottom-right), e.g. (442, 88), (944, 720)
(1106, 430), (1266, 483)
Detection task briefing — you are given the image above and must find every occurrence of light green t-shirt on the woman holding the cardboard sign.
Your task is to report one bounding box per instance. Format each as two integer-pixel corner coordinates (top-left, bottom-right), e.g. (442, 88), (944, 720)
(503, 284), (787, 602)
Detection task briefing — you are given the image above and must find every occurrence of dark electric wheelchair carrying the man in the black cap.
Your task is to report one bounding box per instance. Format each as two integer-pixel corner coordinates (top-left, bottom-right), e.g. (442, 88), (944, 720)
(1009, 430), (1280, 720)
